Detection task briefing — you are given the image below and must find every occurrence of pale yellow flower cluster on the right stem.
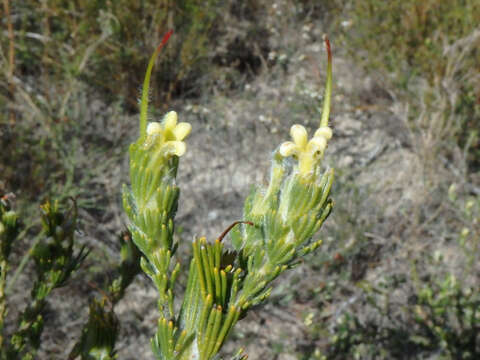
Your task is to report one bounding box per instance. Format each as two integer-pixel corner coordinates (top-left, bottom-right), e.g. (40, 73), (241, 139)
(279, 124), (332, 176)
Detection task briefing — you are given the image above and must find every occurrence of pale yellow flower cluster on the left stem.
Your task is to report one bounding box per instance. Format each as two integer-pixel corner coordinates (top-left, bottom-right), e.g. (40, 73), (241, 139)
(147, 111), (192, 156)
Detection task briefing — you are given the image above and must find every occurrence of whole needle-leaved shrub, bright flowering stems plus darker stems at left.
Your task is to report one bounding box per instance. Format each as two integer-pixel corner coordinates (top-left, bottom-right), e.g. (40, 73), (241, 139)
(0, 32), (333, 360)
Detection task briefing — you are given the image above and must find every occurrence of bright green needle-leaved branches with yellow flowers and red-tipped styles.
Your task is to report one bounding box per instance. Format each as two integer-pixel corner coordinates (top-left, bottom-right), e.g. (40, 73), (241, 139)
(123, 34), (333, 360)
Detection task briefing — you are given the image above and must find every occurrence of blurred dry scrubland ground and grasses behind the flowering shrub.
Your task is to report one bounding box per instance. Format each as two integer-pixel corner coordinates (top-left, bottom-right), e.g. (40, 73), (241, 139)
(0, 0), (480, 360)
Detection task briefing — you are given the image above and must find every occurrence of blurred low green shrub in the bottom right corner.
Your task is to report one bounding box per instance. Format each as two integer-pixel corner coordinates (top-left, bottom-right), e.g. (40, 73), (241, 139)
(304, 185), (480, 359)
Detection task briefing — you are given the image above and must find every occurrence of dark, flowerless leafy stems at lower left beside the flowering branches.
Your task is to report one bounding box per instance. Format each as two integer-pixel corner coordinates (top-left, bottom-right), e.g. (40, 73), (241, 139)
(0, 195), (141, 360)
